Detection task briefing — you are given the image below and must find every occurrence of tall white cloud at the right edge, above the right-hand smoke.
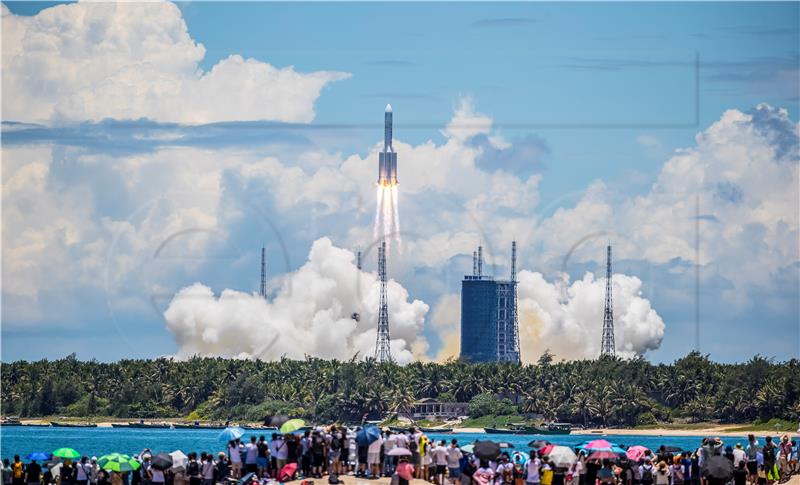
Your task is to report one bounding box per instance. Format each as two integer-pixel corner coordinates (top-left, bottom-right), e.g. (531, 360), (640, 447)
(538, 104), (800, 305)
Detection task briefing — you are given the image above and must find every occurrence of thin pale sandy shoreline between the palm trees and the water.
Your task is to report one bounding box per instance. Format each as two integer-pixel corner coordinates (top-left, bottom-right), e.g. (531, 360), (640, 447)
(12, 418), (800, 437)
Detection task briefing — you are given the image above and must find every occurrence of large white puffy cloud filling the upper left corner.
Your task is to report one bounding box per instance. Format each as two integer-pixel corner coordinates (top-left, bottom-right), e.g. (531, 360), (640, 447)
(2, 2), (349, 124)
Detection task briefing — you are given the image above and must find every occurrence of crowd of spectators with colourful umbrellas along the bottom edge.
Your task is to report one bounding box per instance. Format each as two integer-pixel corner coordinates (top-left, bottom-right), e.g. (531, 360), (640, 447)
(3, 426), (799, 485)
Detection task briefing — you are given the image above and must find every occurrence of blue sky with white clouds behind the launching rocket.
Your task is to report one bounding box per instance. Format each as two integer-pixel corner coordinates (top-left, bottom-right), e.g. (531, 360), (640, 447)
(2, 2), (800, 361)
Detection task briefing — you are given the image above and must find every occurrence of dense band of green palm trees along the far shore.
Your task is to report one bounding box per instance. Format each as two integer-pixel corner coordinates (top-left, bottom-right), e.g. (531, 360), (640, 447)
(0, 353), (800, 430)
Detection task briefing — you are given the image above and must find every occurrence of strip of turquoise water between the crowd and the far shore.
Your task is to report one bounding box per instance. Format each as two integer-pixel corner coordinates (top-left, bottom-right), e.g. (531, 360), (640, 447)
(0, 426), (746, 458)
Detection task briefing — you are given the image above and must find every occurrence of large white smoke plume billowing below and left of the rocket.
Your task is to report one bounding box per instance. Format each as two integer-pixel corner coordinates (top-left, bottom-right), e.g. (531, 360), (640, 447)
(164, 238), (428, 363)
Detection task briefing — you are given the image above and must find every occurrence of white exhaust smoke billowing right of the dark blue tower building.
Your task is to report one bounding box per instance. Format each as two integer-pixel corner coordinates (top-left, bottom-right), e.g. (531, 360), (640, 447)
(518, 271), (664, 362)
